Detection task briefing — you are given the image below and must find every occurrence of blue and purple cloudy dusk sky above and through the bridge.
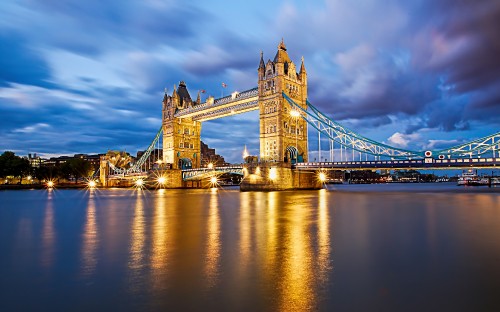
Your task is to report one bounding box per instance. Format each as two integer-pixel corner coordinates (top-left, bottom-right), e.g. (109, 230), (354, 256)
(0, 0), (500, 162)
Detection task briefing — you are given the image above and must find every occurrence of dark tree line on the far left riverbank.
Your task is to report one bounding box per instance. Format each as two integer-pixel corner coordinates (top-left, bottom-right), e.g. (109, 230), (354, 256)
(0, 151), (95, 183)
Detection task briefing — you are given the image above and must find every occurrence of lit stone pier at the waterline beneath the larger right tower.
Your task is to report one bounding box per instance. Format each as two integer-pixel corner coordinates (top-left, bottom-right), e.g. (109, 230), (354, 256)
(240, 162), (323, 192)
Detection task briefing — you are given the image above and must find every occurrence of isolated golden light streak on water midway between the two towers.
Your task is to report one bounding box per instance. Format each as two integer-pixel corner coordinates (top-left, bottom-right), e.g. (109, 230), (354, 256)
(204, 189), (220, 288)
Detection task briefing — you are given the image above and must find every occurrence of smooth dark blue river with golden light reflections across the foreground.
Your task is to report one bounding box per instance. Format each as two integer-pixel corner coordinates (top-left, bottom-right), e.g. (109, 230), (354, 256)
(0, 184), (500, 311)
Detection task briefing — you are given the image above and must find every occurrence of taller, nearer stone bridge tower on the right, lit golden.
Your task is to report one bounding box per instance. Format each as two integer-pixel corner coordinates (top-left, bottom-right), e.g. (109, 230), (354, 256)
(258, 40), (308, 163)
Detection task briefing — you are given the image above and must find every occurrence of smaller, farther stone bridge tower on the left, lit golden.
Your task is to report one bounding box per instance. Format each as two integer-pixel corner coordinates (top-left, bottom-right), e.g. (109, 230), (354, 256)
(162, 81), (201, 169)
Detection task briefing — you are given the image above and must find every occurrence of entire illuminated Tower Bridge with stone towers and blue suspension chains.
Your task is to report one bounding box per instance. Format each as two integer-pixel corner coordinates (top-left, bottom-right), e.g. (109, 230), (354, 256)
(101, 41), (500, 190)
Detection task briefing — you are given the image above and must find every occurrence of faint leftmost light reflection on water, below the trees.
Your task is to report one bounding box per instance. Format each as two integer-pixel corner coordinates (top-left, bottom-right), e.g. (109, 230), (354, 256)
(41, 190), (56, 267)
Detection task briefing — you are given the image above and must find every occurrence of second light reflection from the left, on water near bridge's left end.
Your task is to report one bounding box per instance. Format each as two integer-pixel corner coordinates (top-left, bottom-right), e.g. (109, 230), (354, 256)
(82, 190), (99, 276)
